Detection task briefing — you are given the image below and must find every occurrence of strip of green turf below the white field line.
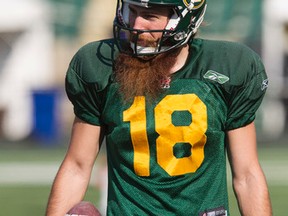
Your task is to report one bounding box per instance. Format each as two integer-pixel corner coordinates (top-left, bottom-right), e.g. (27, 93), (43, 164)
(0, 185), (288, 216)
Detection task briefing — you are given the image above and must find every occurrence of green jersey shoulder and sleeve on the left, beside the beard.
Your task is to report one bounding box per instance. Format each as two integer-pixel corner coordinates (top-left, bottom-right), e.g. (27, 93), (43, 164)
(65, 41), (112, 126)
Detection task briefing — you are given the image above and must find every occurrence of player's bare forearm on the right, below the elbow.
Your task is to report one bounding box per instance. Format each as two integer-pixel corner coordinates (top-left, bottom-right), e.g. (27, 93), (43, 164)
(233, 171), (272, 216)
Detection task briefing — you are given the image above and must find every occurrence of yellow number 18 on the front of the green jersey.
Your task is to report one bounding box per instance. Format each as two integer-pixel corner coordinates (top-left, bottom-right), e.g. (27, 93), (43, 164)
(123, 94), (207, 176)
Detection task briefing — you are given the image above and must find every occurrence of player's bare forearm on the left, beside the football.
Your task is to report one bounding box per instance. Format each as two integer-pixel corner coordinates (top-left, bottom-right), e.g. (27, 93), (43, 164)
(46, 159), (90, 216)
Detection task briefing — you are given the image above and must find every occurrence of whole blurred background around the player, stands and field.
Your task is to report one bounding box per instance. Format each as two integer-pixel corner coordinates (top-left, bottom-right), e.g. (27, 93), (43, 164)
(0, 0), (288, 215)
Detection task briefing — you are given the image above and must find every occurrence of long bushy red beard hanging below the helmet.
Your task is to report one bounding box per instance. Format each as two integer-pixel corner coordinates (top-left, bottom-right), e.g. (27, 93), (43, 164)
(115, 49), (180, 101)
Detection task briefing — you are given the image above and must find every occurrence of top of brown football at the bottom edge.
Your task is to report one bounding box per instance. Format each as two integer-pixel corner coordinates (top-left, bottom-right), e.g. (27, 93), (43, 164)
(66, 201), (101, 216)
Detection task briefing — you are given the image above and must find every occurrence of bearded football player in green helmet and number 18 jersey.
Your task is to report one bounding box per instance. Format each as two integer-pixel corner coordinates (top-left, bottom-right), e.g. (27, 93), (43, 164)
(47, 0), (272, 216)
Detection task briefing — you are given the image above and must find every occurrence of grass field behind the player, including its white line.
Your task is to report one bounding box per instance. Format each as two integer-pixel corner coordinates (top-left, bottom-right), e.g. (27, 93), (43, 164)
(0, 140), (288, 216)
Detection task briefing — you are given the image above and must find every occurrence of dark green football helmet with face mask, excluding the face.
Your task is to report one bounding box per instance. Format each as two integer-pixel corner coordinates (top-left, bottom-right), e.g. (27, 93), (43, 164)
(113, 0), (207, 56)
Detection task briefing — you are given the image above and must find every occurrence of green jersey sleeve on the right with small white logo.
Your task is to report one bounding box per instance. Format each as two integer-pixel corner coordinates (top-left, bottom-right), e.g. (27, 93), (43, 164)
(226, 48), (268, 130)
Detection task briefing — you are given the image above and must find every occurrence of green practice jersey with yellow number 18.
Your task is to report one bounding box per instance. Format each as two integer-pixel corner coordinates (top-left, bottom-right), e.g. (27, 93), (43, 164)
(66, 39), (268, 216)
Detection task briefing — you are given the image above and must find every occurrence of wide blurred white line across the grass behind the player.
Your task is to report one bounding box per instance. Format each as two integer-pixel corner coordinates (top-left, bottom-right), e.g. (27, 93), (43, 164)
(0, 161), (288, 186)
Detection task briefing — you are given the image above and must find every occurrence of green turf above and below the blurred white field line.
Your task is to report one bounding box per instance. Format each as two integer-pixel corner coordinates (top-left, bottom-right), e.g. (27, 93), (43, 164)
(0, 143), (288, 216)
